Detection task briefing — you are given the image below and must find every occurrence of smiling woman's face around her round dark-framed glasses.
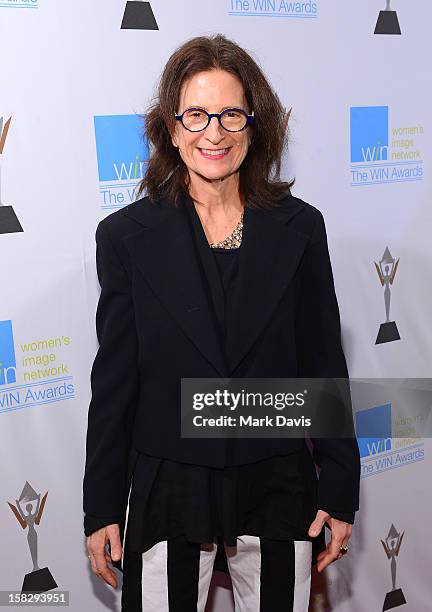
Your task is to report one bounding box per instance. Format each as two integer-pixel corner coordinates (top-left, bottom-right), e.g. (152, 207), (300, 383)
(172, 70), (252, 180)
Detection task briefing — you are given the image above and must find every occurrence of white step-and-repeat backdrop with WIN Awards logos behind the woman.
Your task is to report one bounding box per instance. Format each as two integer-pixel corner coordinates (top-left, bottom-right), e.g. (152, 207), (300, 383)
(0, 0), (432, 612)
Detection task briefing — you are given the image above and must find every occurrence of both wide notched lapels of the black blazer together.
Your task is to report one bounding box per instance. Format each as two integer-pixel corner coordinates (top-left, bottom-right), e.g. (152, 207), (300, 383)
(124, 197), (307, 378)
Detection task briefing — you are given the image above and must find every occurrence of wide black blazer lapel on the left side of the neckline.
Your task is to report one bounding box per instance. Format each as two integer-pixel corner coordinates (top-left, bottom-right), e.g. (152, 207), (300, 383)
(124, 200), (228, 378)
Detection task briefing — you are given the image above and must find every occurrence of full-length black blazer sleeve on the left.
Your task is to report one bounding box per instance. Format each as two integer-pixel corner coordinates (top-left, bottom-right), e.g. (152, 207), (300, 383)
(83, 220), (139, 535)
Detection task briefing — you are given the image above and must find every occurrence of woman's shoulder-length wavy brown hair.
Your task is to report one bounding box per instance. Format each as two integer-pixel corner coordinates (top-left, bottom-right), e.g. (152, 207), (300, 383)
(138, 34), (294, 208)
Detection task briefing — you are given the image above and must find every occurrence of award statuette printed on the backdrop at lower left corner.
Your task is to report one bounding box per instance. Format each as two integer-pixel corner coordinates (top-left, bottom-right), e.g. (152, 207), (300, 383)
(8, 482), (57, 593)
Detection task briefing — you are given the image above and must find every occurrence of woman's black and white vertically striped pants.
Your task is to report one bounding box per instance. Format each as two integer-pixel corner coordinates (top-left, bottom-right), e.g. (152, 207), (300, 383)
(121, 535), (312, 612)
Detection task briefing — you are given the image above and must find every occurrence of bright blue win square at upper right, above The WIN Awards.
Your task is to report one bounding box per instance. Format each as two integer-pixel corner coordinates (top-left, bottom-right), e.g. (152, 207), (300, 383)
(350, 106), (389, 163)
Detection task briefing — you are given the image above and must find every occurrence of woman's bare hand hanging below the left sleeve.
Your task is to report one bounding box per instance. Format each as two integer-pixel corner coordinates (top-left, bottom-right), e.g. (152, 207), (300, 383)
(87, 524), (122, 589)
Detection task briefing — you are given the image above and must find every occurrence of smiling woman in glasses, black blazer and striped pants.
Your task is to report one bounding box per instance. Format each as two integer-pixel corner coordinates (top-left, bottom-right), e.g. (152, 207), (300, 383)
(84, 35), (359, 612)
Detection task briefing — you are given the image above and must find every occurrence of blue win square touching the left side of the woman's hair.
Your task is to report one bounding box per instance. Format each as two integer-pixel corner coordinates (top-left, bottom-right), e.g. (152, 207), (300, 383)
(94, 115), (149, 182)
